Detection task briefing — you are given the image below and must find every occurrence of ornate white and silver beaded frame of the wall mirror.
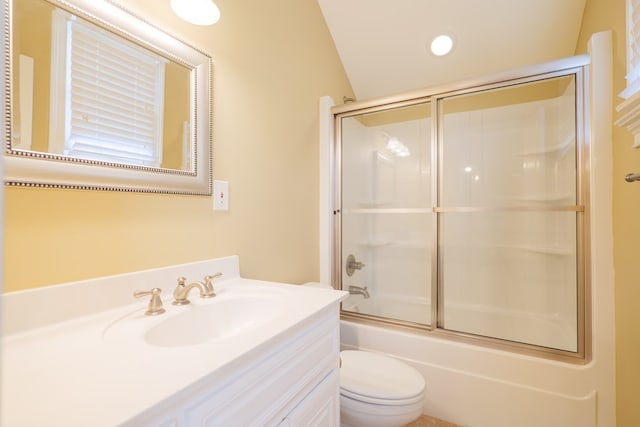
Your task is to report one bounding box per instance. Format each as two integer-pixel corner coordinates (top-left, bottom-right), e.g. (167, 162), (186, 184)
(1, 0), (213, 195)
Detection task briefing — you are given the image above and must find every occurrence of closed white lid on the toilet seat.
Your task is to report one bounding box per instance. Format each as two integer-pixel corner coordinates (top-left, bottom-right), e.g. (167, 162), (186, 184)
(340, 350), (425, 400)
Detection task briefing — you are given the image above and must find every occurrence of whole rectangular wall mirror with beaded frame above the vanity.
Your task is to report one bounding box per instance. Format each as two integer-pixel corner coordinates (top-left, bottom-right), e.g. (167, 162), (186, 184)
(2, 0), (212, 195)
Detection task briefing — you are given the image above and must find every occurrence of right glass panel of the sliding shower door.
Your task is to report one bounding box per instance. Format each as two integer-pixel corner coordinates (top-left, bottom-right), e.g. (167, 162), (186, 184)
(438, 75), (584, 352)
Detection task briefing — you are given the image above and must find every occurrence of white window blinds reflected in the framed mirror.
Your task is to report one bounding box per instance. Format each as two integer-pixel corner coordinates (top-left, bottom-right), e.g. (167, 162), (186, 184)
(64, 15), (164, 167)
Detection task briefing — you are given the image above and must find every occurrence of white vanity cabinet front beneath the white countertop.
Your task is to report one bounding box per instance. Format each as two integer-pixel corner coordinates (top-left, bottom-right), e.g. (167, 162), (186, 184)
(124, 304), (340, 427)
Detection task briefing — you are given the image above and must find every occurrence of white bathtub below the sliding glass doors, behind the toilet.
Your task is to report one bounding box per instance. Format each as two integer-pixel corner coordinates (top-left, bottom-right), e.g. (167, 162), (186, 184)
(341, 308), (597, 427)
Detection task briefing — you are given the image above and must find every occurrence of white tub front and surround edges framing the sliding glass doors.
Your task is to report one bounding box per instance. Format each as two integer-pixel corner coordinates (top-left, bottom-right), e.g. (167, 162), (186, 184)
(320, 32), (616, 427)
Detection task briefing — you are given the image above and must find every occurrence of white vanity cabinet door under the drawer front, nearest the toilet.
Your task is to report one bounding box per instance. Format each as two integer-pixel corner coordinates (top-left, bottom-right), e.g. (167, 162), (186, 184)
(278, 369), (340, 427)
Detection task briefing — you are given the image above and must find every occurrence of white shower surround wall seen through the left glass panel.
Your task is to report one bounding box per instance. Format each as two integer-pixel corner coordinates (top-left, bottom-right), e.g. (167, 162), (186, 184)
(342, 111), (433, 323)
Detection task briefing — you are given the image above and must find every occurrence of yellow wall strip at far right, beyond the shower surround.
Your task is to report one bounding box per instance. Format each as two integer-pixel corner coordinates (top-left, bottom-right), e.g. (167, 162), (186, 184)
(578, 0), (640, 427)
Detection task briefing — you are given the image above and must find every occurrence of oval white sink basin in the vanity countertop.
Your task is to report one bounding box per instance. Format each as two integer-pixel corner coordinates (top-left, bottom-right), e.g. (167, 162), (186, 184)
(144, 297), (281, 347)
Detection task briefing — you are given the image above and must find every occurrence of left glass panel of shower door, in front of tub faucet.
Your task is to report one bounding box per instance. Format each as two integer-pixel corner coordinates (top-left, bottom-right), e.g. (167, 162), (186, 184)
(339, 102), (433, 325)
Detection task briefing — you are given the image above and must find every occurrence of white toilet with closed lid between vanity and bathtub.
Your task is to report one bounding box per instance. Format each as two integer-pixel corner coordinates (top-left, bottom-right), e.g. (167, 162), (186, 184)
(305, 283), (425, 427)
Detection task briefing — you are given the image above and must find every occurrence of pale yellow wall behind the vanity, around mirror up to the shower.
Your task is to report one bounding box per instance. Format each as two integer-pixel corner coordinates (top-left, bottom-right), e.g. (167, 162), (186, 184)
(4, 0), (353, 291)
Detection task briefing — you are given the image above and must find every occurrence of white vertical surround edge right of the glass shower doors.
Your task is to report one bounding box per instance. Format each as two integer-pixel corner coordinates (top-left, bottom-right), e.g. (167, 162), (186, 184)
(589, 31), (616, 426)
